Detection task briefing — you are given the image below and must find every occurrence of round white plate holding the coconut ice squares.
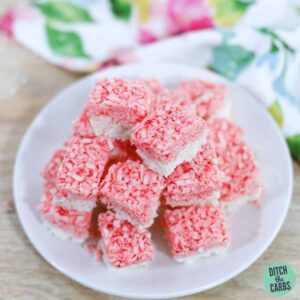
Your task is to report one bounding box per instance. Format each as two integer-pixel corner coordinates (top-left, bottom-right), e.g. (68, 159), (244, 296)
(14, 64), (293, 299)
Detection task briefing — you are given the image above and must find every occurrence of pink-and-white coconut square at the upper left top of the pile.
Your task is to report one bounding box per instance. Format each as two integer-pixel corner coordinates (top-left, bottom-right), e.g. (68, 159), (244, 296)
(87, 79), (152, 140)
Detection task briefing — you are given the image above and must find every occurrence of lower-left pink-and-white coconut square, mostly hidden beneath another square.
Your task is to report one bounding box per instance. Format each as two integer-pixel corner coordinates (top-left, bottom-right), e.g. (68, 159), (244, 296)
(39, 183), (95, 243)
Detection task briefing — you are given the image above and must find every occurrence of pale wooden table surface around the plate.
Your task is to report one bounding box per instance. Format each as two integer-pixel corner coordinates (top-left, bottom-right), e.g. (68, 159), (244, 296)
(0, 0), (300, 300)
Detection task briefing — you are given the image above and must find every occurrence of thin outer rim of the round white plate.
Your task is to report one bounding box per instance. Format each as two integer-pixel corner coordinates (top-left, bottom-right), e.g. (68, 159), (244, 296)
(13, 62), (294, 299)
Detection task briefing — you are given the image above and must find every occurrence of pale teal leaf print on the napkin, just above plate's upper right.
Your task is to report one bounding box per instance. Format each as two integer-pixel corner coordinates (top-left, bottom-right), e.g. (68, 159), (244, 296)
(210, 44), (255, 80)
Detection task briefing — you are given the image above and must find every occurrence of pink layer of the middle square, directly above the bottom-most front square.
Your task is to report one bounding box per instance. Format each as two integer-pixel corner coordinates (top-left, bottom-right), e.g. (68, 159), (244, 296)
(101, 160), (165, 226)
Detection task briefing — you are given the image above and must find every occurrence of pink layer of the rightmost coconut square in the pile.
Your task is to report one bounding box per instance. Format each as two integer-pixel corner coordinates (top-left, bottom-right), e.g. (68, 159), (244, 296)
(209, 119), (261, 201)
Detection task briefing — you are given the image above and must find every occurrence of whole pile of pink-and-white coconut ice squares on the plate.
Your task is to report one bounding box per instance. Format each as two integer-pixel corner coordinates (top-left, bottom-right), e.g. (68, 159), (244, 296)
(40, 78), (262, 268)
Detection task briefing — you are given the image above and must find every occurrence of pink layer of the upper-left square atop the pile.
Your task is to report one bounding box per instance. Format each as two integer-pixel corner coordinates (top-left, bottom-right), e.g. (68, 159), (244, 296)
(87, 79), (152, 124)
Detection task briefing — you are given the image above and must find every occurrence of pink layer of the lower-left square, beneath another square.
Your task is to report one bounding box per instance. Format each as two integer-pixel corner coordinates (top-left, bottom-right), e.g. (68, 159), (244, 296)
(40, 184), (92, 240)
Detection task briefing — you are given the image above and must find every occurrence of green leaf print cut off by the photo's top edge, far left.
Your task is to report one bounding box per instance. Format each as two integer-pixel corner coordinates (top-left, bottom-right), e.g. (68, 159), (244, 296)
(35, 0), (94, 23)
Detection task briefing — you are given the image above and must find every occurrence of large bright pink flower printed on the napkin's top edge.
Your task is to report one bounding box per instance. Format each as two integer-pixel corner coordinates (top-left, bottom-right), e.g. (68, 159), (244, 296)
(167, 0), (214, 34)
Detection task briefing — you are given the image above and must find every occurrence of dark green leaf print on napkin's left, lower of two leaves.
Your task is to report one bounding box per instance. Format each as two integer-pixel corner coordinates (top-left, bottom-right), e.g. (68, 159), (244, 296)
(46, 25), (89, 58)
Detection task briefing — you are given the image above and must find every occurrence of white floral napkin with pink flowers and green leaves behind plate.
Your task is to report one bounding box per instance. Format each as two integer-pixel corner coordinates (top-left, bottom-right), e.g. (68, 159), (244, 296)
(0, 0), (300, 161)
